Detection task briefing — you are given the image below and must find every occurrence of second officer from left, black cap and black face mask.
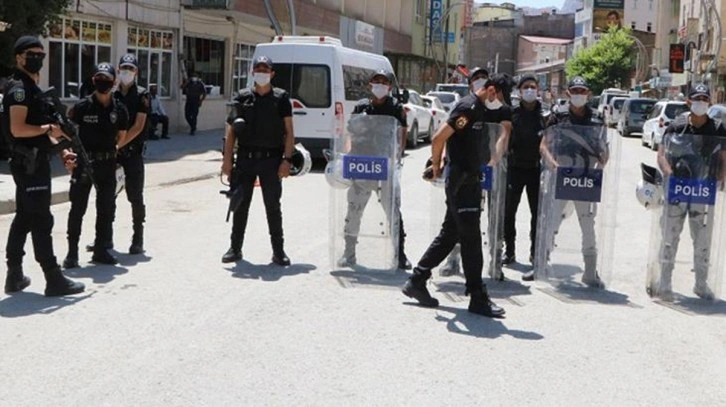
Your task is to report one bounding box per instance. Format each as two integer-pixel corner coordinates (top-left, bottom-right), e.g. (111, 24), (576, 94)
(63, 62), (129, 269)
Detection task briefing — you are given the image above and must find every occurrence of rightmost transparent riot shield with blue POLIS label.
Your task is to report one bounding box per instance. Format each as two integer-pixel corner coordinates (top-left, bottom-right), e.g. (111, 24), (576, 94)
(646, 133), (726, 301)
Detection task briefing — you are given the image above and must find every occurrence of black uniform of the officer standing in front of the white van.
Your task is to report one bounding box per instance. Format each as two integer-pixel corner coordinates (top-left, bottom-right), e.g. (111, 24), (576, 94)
(227, 88), (292, 259)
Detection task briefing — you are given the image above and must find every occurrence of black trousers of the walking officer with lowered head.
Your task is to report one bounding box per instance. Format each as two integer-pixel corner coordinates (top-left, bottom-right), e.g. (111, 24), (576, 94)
(418, 169), (484, 293)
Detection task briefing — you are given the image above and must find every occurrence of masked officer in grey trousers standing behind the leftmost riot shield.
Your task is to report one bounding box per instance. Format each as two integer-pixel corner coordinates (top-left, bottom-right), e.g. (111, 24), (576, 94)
(338, 69), (411, 270)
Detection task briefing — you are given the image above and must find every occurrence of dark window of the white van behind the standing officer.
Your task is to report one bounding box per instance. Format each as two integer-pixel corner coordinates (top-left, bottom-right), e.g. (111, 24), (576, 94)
(272, 63), (331, 109)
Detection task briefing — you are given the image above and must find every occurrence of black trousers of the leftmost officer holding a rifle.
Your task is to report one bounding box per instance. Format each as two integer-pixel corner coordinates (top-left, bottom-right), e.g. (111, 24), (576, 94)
(5, 153), (58, 270)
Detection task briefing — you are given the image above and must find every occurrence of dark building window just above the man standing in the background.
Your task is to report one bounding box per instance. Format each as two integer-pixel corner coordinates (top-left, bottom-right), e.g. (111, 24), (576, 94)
(184, 37), (226, 96)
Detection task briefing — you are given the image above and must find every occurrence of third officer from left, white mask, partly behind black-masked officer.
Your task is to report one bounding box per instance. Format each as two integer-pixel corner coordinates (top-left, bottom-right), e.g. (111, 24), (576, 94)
(107, 54), (150, 254)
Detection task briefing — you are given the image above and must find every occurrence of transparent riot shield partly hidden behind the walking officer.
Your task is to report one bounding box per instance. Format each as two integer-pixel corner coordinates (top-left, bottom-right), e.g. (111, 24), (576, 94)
(431, 123), (507, 277)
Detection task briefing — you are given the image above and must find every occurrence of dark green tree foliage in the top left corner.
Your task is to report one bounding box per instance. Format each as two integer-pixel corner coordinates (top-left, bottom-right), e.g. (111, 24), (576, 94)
(0, 0), (71, 76)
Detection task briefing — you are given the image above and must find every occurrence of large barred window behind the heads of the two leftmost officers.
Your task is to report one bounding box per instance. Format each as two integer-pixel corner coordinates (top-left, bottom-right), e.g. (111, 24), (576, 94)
(48, 18), (114, 98)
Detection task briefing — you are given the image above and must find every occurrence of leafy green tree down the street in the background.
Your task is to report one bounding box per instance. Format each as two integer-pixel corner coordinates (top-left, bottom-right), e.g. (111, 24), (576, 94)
(565, 27), (636, 95)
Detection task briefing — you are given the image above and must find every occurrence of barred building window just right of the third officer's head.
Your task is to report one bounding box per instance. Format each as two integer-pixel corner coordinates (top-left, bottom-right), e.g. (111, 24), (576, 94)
(127, 27), (174, 97)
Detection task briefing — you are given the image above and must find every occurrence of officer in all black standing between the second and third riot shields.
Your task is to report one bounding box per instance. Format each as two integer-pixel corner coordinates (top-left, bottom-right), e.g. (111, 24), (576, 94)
(502, 75), (545, 276)
